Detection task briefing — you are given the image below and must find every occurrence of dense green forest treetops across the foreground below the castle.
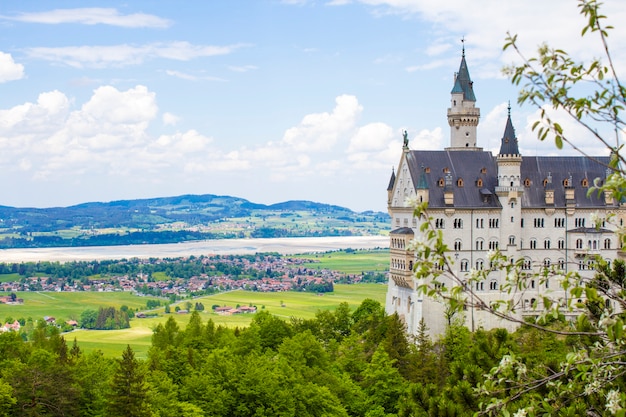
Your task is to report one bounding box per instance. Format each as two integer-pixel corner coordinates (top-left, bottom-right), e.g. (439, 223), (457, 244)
(0, 300), (600, 417)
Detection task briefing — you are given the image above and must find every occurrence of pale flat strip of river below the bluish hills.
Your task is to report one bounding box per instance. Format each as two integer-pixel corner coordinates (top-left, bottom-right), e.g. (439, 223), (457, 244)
(0, 236), (389, 262)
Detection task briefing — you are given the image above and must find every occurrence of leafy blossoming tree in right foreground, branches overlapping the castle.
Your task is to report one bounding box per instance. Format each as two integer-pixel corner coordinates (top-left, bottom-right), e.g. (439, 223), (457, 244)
(414, 0), (626, 416)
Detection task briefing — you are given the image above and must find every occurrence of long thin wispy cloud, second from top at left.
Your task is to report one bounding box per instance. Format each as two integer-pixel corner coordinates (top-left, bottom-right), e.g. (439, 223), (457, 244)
(26, 42), (245, 68)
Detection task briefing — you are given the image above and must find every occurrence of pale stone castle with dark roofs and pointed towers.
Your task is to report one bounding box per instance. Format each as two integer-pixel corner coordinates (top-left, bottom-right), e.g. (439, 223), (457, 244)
(386, 48), (624, 335)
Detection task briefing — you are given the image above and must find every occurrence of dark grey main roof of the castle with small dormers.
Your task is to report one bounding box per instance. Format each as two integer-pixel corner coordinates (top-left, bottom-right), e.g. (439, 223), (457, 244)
(406, 150), (609, 208)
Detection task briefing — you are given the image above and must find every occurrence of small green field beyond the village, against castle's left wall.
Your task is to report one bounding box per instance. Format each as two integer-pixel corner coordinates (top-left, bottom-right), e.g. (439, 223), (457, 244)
(295, 249), (389, 274)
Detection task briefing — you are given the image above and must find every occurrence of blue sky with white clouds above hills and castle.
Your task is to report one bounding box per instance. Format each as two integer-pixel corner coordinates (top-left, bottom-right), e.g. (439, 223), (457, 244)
(0, 0), (626, 211)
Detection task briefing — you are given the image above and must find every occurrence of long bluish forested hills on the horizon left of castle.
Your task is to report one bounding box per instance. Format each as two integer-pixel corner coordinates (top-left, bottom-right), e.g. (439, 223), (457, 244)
(0, 194), (389, 248)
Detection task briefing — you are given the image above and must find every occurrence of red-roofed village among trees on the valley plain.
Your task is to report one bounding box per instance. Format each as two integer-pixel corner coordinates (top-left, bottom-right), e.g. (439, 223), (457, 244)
(0, 254), (384, 303)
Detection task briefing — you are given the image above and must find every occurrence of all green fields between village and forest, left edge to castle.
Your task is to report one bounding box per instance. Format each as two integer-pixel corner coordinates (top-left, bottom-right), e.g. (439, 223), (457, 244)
(0, 284), (387, 358)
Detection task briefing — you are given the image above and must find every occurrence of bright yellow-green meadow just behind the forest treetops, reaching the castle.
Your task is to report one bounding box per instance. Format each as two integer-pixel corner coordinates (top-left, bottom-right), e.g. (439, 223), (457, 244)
(59, 284), (387, 358)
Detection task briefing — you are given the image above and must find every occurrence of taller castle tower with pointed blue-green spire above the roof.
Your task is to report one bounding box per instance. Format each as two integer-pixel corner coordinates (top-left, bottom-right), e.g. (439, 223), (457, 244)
(446, 45), (482, 151)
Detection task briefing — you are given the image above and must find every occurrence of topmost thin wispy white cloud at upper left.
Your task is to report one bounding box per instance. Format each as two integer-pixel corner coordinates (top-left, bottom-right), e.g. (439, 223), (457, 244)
(1, 7), (172, 28)
